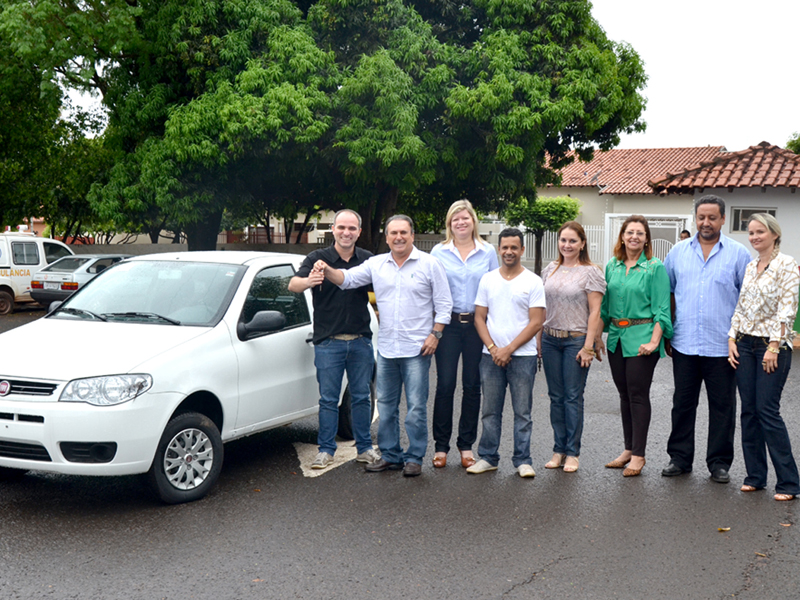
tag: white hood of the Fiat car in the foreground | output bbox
[0,318,217,381]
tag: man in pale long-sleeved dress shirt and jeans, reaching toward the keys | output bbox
[315,215,453,477]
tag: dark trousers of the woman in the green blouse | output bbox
[608,342,660,456]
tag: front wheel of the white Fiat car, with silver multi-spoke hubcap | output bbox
[148,412,223,504]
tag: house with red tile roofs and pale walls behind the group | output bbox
[538,142,800,262]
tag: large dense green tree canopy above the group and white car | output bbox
[0,0,646,248]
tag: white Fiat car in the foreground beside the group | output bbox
[0,252,377,503]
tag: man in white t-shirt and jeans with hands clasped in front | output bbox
[467,228,545,477]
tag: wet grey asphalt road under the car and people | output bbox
[0,311,800,600]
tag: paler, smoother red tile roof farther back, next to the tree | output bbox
[561,146,725,194]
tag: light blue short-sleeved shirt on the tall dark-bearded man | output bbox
[664,234,750,357]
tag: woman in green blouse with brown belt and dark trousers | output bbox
[601,215,672,477]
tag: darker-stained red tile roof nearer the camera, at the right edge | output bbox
[649,142,800,194]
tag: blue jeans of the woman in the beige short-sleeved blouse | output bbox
[542,333,589,456]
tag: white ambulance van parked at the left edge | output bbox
[0,232,74,315]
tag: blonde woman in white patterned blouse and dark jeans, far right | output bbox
[728,213,800,500]
